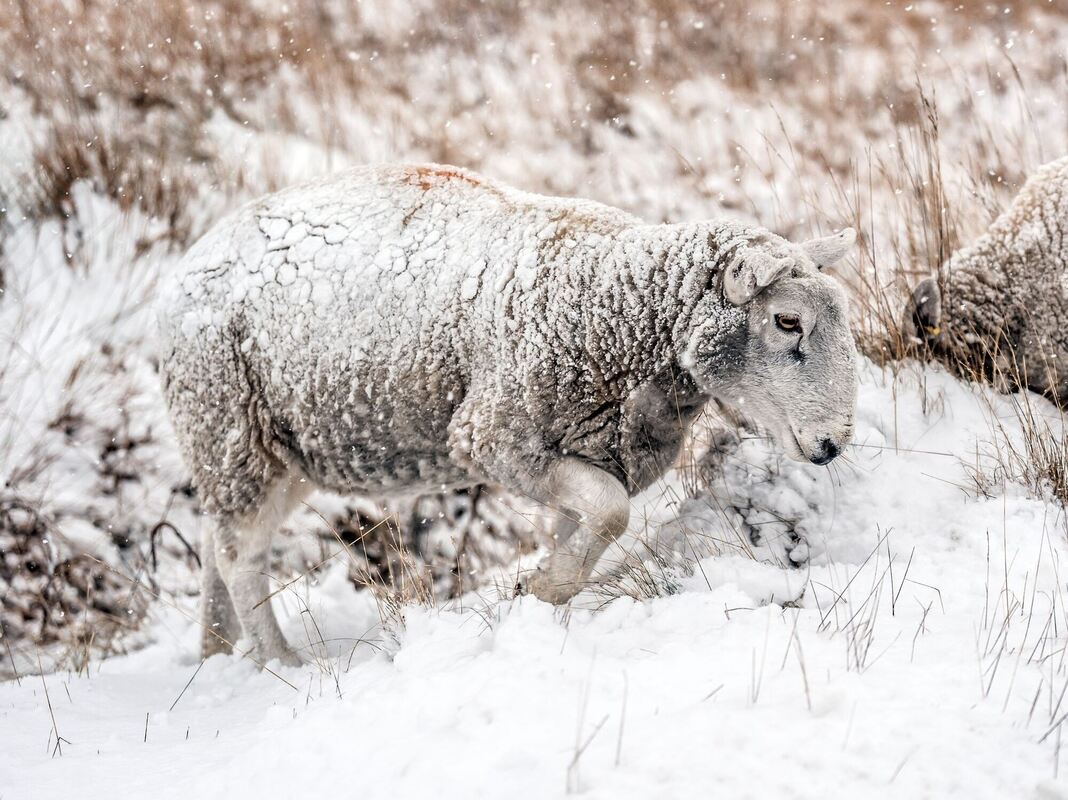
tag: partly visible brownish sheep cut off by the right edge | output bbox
[902,157,1068,406]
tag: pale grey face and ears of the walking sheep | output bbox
[684,229,857,464]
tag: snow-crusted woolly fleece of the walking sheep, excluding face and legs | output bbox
[160,166,796,516]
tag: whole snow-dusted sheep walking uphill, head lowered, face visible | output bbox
[159,164,857,665]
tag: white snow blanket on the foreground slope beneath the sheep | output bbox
[0,364,1068,800]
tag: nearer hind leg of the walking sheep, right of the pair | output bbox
[214,480,308,666]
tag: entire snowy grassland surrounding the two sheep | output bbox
[0,0,1068,798]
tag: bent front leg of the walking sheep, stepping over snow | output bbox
[520,458,630,605]
